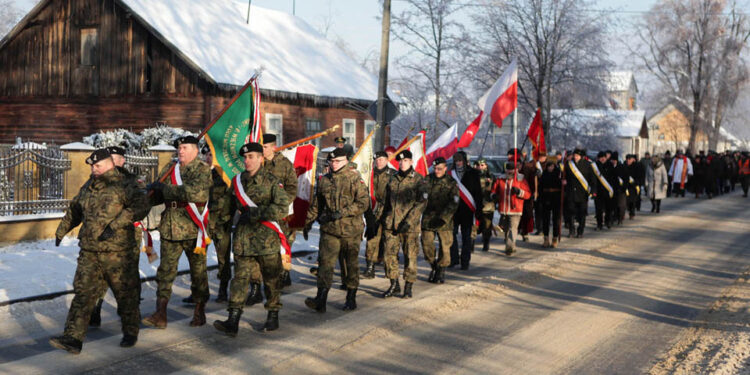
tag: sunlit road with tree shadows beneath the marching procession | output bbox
[0,194,750,374]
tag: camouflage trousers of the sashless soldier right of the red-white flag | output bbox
[318,233,362,289]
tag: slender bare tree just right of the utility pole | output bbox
[391,0,463,131]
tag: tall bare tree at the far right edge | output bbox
[632,0,748,151]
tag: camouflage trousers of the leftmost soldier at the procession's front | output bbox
[65,250,141,341]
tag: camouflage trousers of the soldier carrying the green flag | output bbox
[156,239,208,302]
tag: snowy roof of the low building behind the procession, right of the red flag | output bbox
[551,109,646,138]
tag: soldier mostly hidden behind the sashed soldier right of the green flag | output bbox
[260,134,297,290]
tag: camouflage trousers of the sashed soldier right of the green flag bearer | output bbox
[229,253,283,311]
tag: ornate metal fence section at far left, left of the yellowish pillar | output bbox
[0,139,70,216]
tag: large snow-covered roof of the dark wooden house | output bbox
[120,0,401,102]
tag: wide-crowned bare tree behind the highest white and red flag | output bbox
[465,0,611,140]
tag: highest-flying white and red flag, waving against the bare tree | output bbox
[475,59,518,128]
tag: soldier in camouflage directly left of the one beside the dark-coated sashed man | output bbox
[383,150,428,298]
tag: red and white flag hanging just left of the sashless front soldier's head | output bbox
[281,144,318,228]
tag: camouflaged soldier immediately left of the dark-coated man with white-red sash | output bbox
[422,157,460,284]
